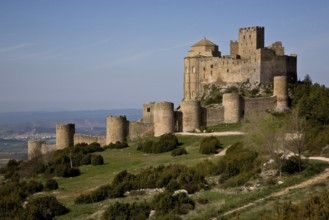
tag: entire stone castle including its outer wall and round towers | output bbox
[28,27,297,159]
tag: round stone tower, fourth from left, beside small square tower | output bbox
[154,102,175,137]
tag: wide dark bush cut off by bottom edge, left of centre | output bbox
[102,202,151,220]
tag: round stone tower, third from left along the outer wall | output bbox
[106,115,127,144]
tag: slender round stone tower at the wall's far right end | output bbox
[273,76,289,112]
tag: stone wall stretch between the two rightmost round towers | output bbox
[243,96,276,117]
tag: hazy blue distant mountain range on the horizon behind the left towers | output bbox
[0,109,142,138]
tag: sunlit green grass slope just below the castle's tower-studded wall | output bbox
[56,135,242,207]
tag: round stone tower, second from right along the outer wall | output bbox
[223,93,241,123]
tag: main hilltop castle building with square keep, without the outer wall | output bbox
[184,27,297,100]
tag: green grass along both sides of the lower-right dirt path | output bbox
[186,161,329,219]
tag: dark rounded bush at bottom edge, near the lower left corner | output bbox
[26,196,69,219]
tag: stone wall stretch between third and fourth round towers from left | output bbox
[128,121,154,140]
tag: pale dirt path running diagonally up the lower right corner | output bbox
[222,157,329,216]
